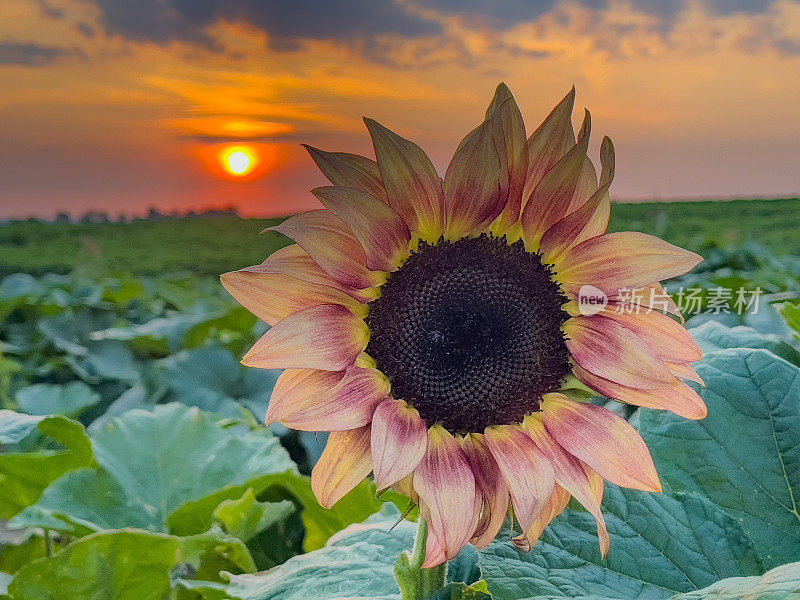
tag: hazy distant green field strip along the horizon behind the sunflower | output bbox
[0,198,800,277]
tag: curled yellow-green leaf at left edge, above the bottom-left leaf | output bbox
[0,411,93,519]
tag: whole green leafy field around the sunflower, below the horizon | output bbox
[0,200,800,600]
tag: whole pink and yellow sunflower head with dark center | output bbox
[222,84,706,567]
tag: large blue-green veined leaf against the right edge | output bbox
[640,349,800,568]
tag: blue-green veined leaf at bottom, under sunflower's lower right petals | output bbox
[478,484,763,600]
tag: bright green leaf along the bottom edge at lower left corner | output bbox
[8,529,252,600]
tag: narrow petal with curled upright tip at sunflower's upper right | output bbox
[539,137,614,264]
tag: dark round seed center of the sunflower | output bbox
[367,235,570,433]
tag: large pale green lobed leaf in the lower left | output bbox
[14,404,293,535]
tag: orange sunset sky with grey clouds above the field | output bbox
[0,0,800,218]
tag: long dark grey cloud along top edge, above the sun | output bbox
[87,0,440,47]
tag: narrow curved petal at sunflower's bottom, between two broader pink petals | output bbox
[461,433,511,548]
